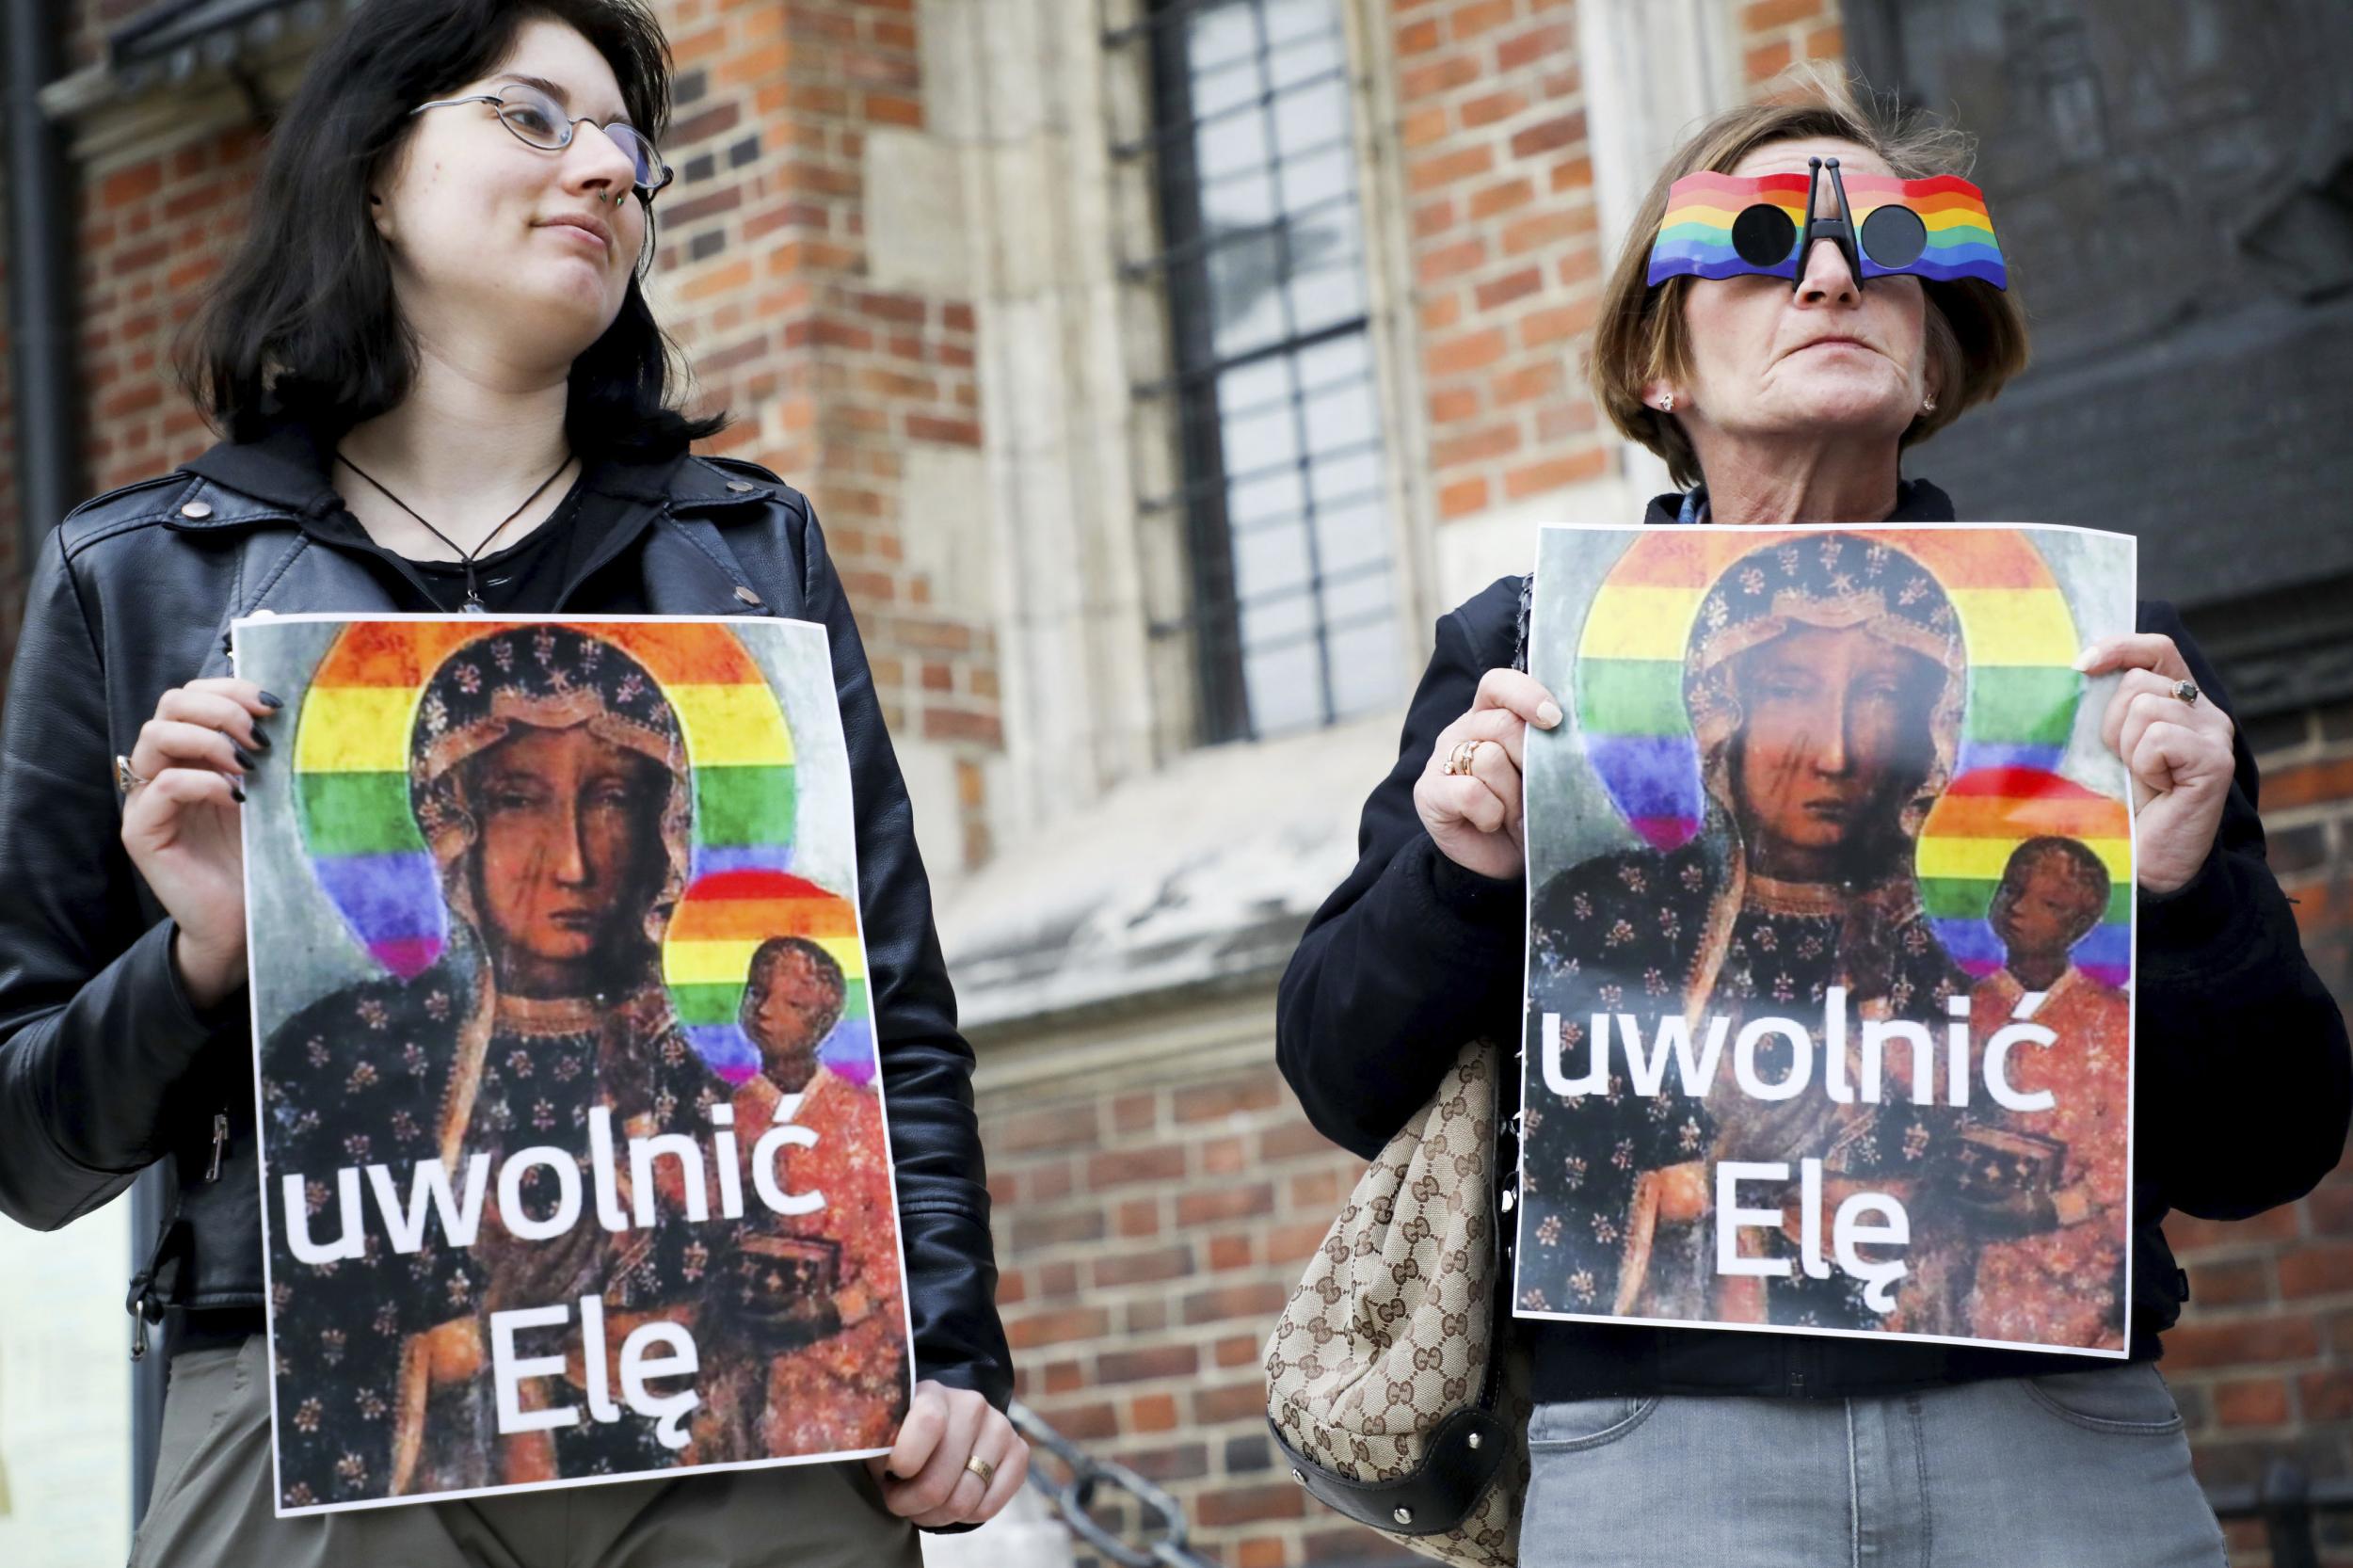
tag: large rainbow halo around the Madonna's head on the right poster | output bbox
[1572,527,2085,850]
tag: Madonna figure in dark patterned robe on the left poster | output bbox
[262,626,758,1507]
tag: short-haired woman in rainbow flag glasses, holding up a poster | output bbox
[1278,79,2353,1568]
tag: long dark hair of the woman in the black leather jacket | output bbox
[179,0,728,459]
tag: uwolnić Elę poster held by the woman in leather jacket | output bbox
[235,615,911,1516]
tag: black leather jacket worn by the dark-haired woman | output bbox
[0,424,1012,1408]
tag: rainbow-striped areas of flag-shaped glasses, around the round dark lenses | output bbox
[1650,172,2009,290]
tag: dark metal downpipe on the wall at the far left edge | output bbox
[0,0,83,567]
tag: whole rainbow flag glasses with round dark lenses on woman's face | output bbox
[1650,158,2009,290]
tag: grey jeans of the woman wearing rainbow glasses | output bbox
[1520,1363,2224,1568]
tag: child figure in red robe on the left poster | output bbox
[734,937,908,1452]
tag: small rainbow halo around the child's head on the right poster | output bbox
[1918,767,2132,986]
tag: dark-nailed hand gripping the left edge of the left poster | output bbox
[122,678,282,1008]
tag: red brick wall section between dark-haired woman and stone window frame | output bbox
[662,0,1002,864]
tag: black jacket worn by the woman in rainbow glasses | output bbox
[1275,483,2353,1399]
